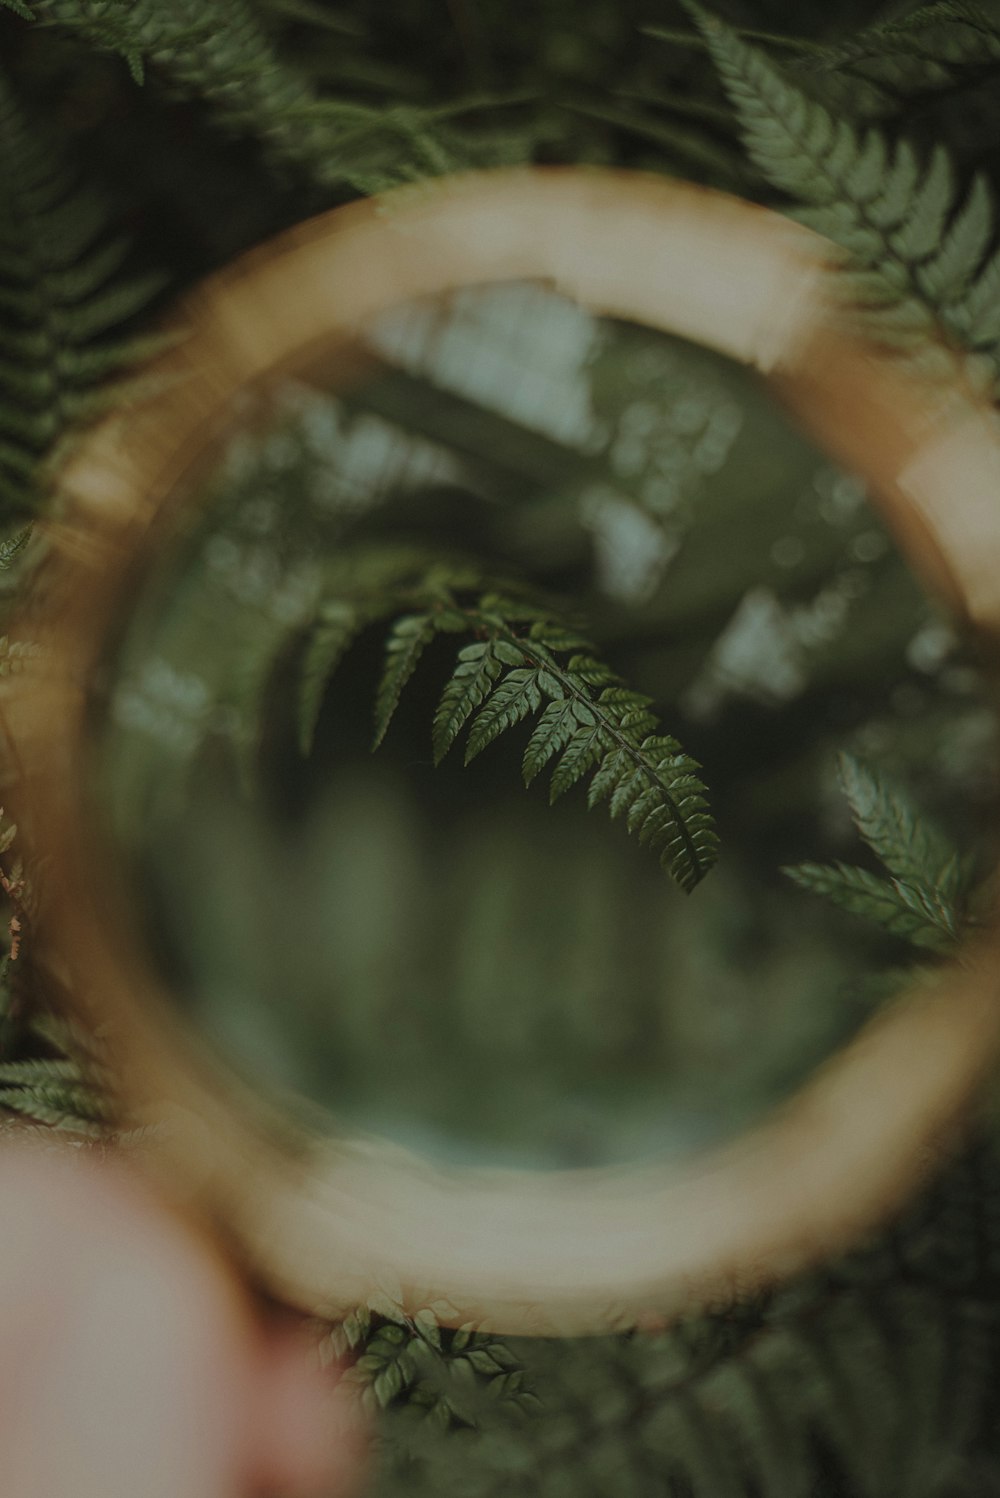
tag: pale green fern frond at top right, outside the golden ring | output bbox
[689,3,1000,376]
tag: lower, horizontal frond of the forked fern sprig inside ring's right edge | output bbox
[781,861,958,953]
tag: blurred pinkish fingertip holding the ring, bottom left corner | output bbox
[0,1146,364,1498]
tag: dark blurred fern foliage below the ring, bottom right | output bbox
[350,1141,1000,1498]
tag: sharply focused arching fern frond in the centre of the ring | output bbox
[299,569,719,890]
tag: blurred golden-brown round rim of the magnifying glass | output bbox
[11,169,1000,1333]
